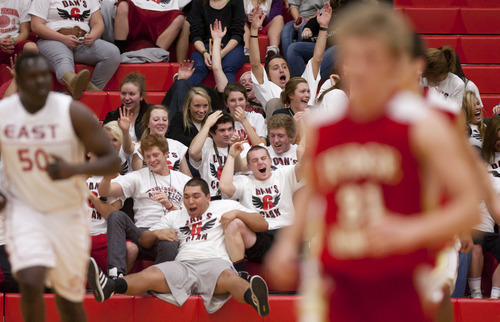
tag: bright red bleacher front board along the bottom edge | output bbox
[0,294,500,322]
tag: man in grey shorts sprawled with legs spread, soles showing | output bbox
[88,178,269,316]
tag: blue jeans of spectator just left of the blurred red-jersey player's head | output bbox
[287,41,337,80]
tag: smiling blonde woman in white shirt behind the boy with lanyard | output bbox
[133,105,192,177]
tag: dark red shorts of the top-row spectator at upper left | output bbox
[117,0,184,43]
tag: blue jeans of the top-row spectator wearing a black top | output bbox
[189,44,245,85]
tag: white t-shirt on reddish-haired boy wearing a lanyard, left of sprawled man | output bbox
[111,168,191,227]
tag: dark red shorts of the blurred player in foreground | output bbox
[327,274,433,322]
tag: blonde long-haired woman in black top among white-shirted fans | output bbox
[167,87,212,146]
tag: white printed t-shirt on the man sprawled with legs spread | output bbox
[149,200,253,261]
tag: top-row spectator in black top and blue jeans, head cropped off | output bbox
[189,0,245,85]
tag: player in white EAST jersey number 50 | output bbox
[0,53,120,321]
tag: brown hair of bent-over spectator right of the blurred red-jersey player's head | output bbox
[423,46,457,81]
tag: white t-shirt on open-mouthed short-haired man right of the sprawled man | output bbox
[231,166,302,230]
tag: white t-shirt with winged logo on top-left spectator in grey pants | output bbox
[29,0,101,32]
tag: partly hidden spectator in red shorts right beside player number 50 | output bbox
[86,152,139,270]
